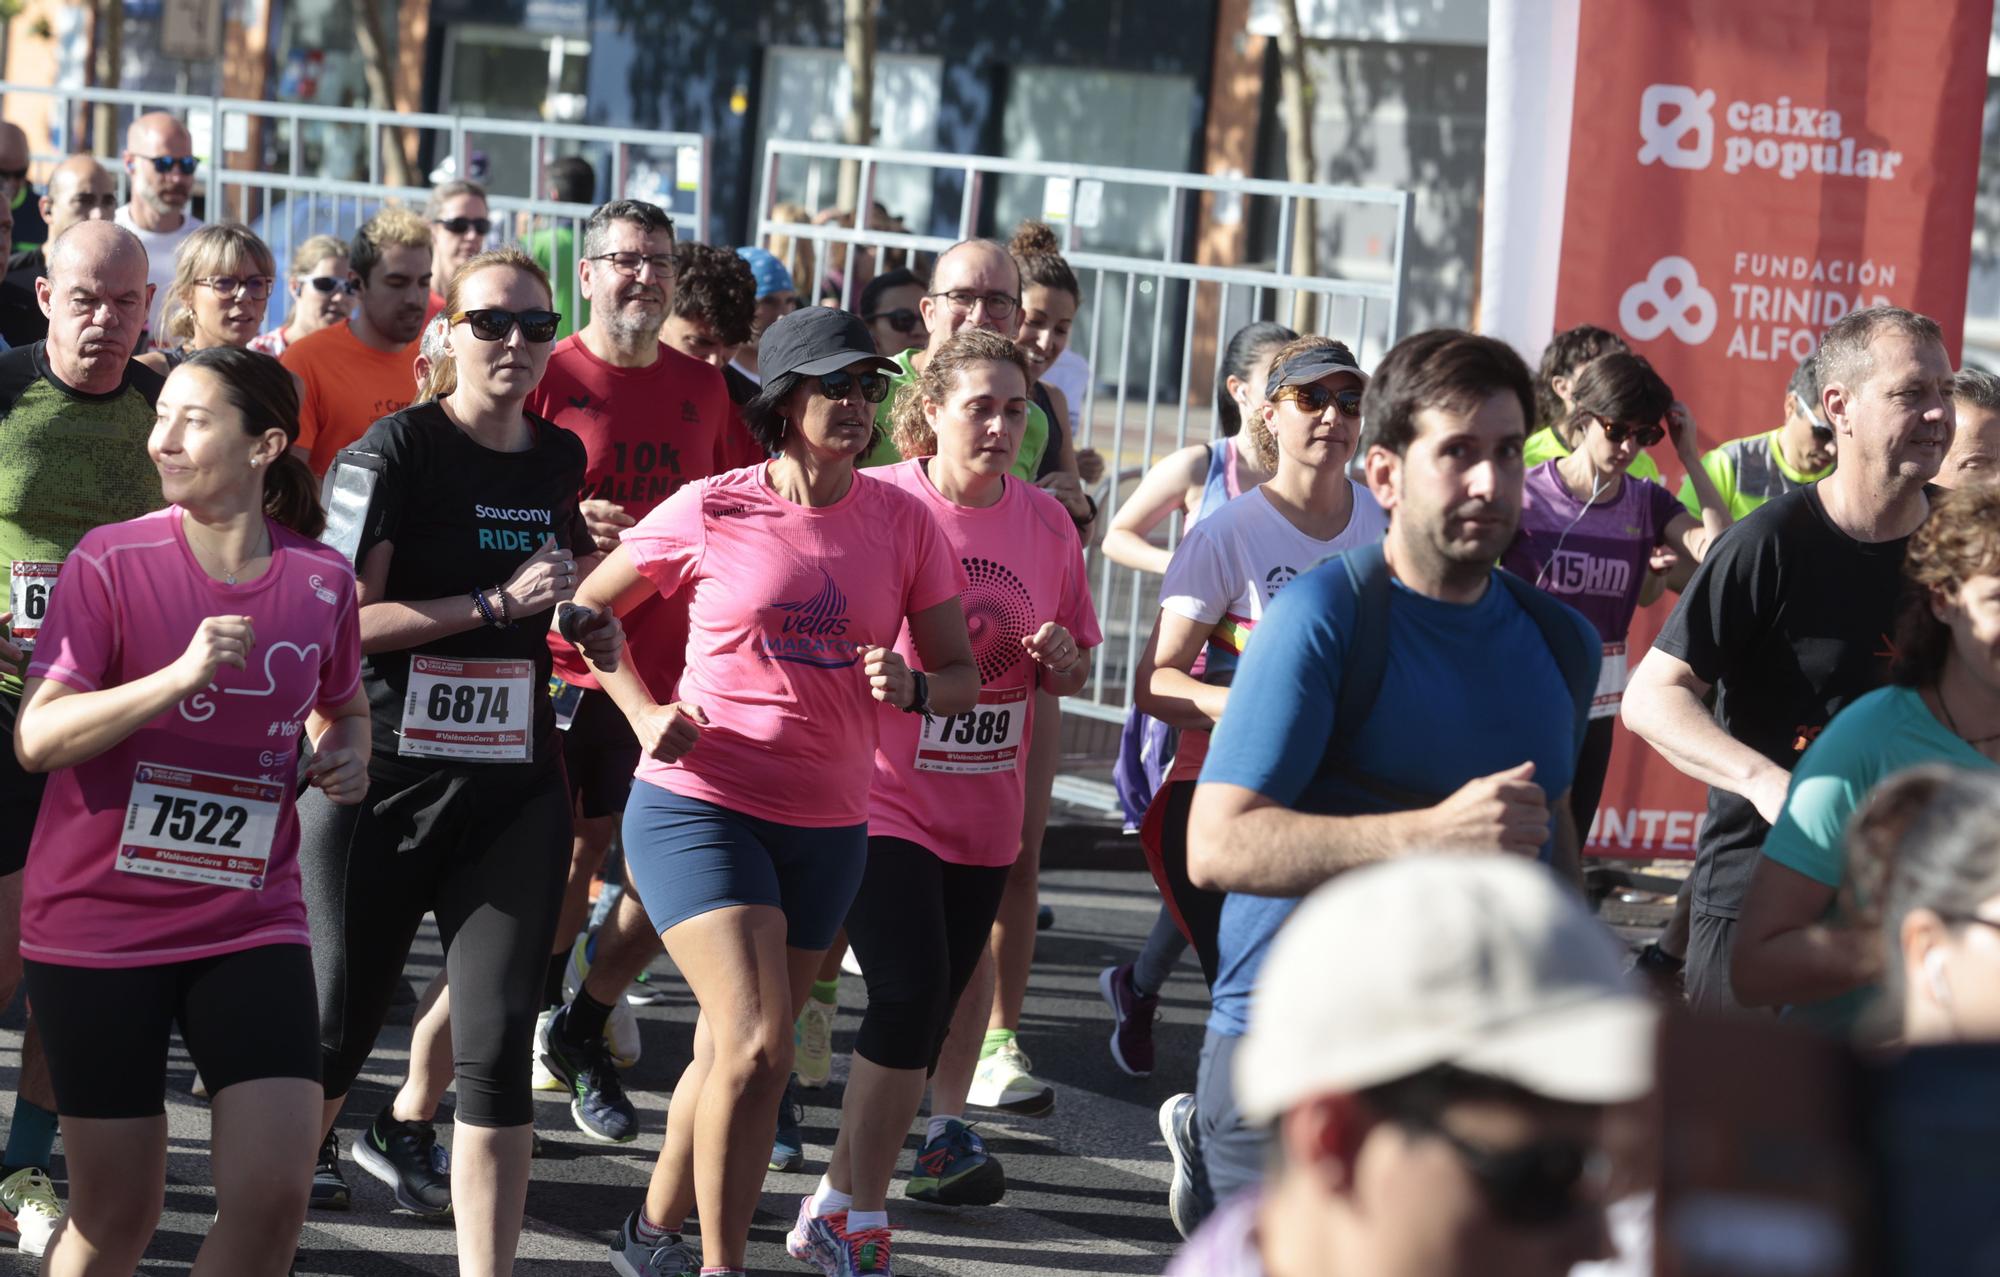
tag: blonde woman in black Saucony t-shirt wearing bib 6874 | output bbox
[300,250,618,1275]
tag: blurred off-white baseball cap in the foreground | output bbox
[1236,855,1656,1121]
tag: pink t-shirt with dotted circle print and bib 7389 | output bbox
[868,460,1104,865]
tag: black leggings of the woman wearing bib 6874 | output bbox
[298,759,570,1127]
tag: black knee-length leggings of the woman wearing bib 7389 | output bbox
[848,839,1008,1071]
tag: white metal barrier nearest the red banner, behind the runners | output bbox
[750,140,1410,760]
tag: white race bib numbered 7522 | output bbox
[118,763,284,891]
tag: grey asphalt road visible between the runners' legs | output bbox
[0,869,1206,1277]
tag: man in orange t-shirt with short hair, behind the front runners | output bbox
[280,208,430,474]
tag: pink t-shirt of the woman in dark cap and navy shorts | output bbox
[622,464,966,829]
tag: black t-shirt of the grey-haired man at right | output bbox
[1654,486,1910,919]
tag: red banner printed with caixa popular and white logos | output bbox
[1554,0,1992,857]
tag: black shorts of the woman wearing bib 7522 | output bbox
[24,945,320,1119]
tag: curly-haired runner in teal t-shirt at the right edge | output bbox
[1730,484,2000,1035]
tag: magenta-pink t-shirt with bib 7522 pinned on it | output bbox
[20,506,360,967]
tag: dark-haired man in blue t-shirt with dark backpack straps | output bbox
[1160,330,1602,1227]
